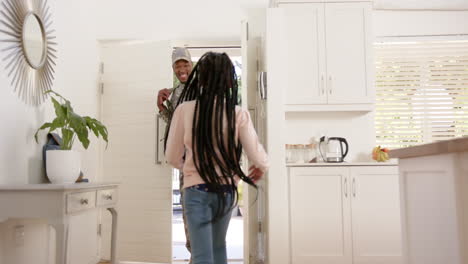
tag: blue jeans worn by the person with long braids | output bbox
[183,188,233,264]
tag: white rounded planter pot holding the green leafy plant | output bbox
[46,150,81,184]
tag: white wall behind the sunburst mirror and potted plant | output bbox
[0,0,99,264]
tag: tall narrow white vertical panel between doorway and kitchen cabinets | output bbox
[265,8,290,264]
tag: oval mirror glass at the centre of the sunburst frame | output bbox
[23,13,46,69]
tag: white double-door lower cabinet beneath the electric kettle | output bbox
[288,166,403,264]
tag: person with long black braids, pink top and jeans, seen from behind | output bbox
[166,52,268,264]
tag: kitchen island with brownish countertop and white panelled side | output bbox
[390,137,468,264]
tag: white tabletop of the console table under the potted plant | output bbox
[0,182,119,192]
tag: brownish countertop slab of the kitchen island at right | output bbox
[389,137,468,159]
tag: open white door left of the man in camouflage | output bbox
[101,41,173,263]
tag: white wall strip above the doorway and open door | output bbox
[97,0,267,41]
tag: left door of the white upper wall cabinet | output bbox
[283,4,327,104]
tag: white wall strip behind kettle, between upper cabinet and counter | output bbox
[286,112,375,162]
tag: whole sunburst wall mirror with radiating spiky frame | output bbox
[0,0,57,105]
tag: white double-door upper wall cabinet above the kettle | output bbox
[279,3,373,111]
